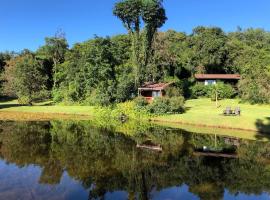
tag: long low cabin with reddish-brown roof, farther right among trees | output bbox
[195,74,241,85]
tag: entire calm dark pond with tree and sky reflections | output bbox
[0,121,270,200]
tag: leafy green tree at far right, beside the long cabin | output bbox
[226,29,270,103]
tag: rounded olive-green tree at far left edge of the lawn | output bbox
[4,53,48,104]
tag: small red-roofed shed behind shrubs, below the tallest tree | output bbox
[138,83,172,101]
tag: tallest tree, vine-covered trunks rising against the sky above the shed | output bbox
[113,0,167,86]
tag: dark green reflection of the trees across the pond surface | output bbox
[0,121,270,199]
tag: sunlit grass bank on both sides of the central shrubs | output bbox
[0,99,270,133]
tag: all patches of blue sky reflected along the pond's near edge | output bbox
[0,160,269,200]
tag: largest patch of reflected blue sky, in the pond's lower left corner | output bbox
[0,161,88,200]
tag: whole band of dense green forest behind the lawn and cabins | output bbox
[0,0,270,105]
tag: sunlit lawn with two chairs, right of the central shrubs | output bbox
[154,99,270,133]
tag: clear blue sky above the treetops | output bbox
[0,0,270,51]
